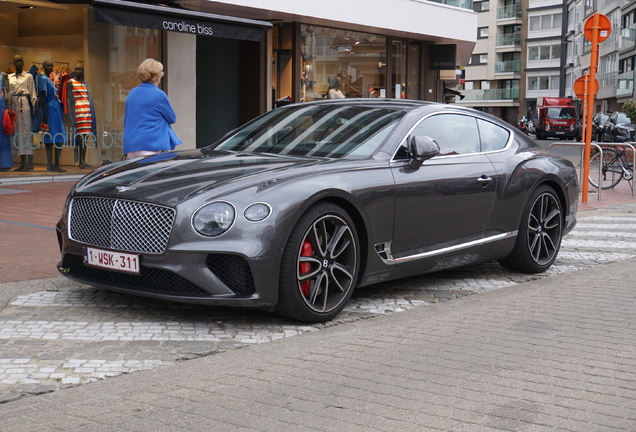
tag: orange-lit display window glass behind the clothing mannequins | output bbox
[0,5,162,166]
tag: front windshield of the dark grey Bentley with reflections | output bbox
[214,104,405,159]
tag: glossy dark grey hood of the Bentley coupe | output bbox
[74,149,333,206]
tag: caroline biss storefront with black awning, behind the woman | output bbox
[0,1,271,171]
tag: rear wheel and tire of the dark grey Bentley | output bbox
[499,186,564,273]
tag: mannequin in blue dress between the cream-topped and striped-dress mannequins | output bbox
[38,60,66,172]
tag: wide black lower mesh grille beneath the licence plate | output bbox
[62,254,210,297]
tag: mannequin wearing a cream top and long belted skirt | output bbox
[9,55,37,171]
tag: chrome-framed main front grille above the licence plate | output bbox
[69,197,175,254]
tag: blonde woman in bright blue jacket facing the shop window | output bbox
[124,59,181,159]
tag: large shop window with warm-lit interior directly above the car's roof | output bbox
[300,25,389,101]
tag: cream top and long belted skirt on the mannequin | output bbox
[9,71,37,156]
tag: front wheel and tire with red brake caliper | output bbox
[275,203,360,323]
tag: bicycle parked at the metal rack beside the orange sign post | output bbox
[588,146,634,190]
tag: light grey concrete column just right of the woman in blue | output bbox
[164,32,197,150]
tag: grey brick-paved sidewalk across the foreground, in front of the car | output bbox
[0,255,636,432]
